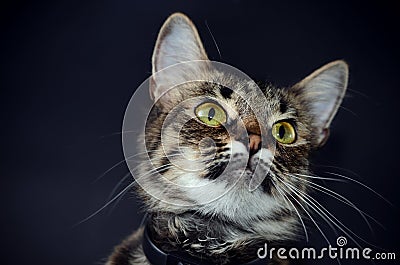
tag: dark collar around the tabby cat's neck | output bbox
[142,218,267,265]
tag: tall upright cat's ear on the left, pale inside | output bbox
[150,13,208,99]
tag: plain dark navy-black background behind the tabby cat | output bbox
[0,0,400,265]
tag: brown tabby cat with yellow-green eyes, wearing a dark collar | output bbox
[106,13,348,265]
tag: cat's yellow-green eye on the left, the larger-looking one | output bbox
[195,102,226,127]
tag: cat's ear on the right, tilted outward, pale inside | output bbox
[293,60,349,146]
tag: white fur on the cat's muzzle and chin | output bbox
[177,141,281,224]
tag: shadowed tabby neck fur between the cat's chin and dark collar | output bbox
[148,209,266,264]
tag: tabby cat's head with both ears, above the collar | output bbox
[134,14,348,237]
